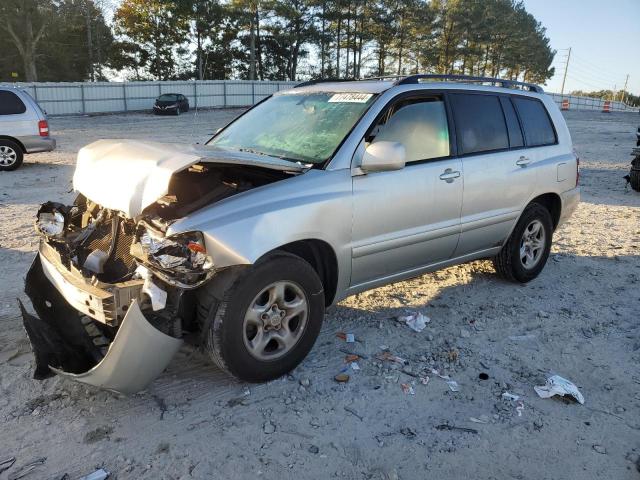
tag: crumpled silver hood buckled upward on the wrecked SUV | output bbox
[73,140,306,218]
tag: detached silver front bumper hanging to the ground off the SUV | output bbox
[20,254,182,394]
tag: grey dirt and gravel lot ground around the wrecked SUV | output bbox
[0,110,640,480]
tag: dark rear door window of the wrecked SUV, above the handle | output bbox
[451,93,509,154]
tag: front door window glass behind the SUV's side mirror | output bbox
[372,98,449,162]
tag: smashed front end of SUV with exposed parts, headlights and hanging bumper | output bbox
[22,195,213,394]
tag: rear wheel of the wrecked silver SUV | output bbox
[493,203,553,283]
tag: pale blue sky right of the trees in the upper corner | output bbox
[524,0,640,95]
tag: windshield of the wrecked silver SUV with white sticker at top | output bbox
[209,92,375,163]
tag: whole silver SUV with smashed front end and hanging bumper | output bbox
[23,75,580,393]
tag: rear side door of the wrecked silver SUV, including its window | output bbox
[450,92,536,257]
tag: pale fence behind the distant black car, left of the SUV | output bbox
[7,80,298,115]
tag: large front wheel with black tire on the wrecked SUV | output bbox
[197,252,324,382]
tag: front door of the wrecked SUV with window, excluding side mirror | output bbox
[351,94,462,287]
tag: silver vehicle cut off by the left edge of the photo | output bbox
[0,85,56,171]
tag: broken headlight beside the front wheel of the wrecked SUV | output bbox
[140,230,213,281]
